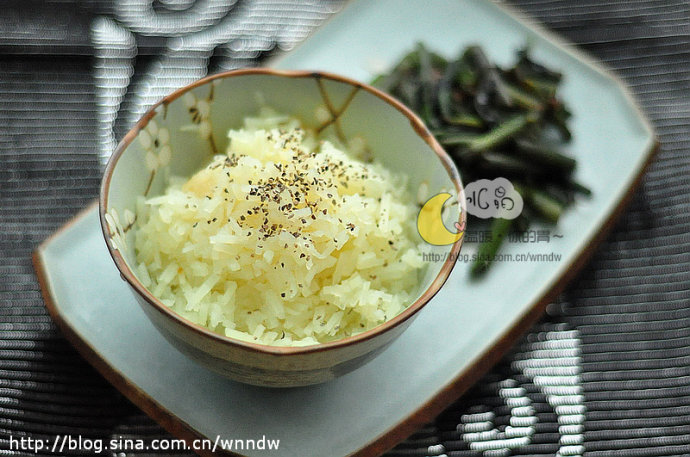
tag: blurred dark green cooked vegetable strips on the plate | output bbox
[372,43,590,276]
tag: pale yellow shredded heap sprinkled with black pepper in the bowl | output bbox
[135,109,423,346]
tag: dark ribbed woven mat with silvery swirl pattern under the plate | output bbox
[0,0,690,457]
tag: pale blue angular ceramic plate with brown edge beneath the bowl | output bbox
[35,0,656,457]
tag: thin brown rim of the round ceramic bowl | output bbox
[98,67,467,355]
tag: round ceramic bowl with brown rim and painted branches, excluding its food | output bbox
[99,69,465,387]
